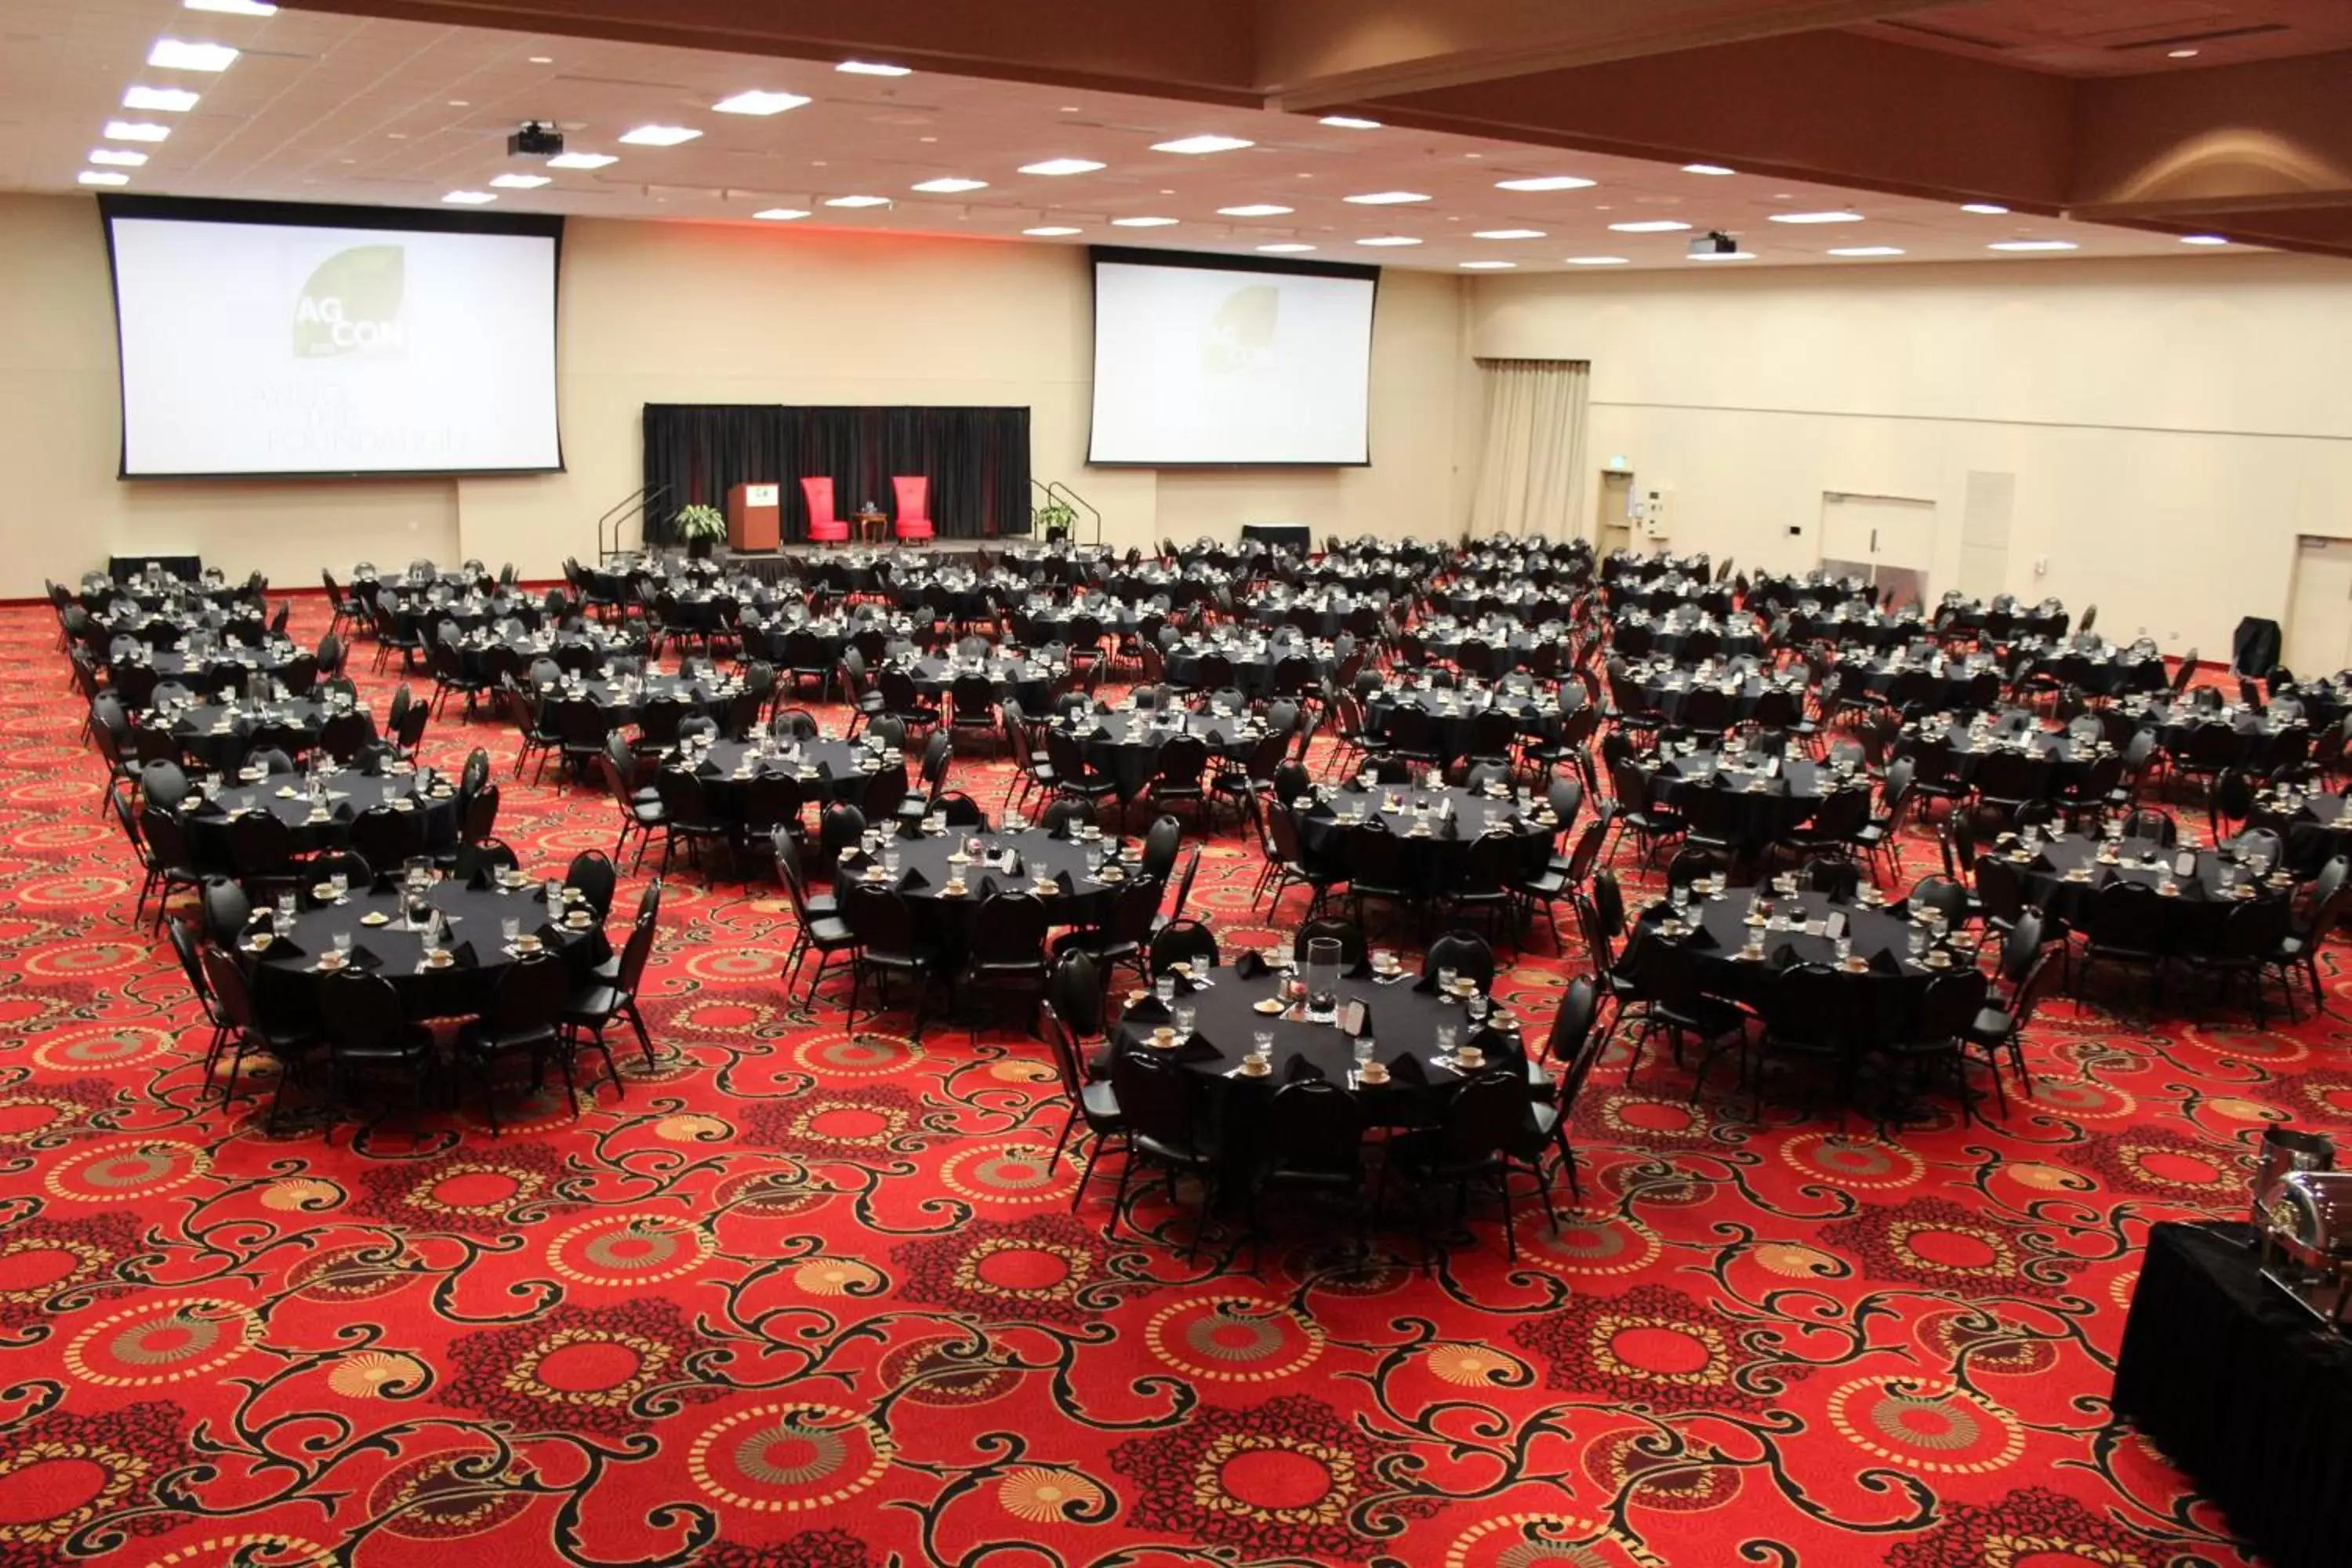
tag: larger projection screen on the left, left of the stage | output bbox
[101,198,562,480]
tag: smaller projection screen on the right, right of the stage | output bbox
[1087,247,1381,468]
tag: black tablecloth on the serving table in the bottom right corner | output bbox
[2114,1225,2352,1568]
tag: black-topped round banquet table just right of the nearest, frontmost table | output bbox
[1637,886,1966,1041]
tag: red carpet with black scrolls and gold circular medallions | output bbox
[0,600,2314,1568]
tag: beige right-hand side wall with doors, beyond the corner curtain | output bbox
[1468,256,2352,659]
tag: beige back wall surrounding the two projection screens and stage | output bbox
[0,198,1475,597]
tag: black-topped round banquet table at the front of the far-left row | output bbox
[240,881,604,1020]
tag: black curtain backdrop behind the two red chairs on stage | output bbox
[644,402,1030,546]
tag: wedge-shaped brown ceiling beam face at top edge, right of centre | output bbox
[1258,0,1940,113]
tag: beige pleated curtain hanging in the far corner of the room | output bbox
[1470,360,1592,541]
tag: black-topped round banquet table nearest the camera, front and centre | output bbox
[1115,966,1524,1123]
